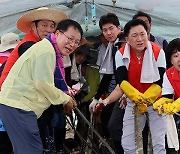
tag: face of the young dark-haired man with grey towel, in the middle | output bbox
[102,23,121,42]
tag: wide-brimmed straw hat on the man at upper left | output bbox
[17,7,68,33]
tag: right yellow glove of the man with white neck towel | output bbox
[144,84,162,106]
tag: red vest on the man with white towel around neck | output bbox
[120,42,161,93]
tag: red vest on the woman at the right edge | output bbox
[166,66,180,98]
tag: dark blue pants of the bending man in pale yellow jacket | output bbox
[0,104,43,154]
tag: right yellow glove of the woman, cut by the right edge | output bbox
[163,98,180,114]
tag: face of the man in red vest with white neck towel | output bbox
[126,25,148,53]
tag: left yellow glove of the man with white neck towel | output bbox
[120,80,146,104]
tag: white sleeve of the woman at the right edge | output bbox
[162,72,174,95]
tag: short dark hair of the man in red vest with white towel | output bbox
[124,19,148,37]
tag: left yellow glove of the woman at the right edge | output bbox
[153,97,173,114]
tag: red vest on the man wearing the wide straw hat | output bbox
[0,30,39,88]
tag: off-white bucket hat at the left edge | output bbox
[0,33,20,52]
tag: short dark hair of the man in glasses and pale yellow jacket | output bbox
[56,19,83,38]
